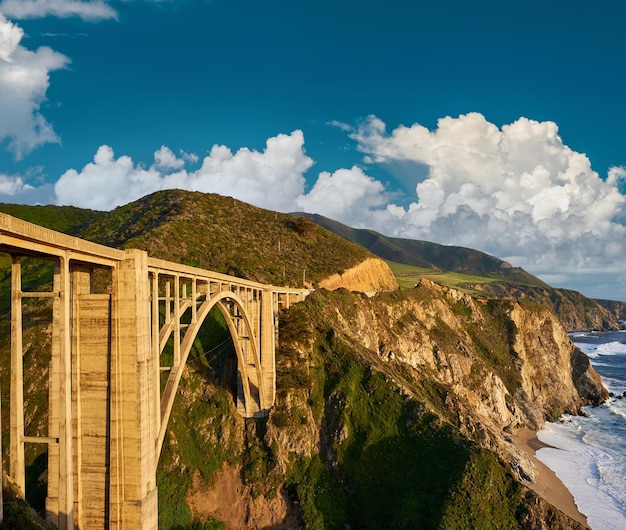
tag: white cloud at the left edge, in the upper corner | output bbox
[0,14,69,158]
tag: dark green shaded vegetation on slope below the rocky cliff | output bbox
[271,294,523,529]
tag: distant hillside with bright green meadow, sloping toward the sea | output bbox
[295,213,622,331]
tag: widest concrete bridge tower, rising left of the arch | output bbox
[110,250,160,530]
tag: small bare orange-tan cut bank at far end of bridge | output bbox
[319,258,398,292]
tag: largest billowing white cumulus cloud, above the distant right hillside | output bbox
[351,113,626,271]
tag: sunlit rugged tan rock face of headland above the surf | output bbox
[292,280,608,438]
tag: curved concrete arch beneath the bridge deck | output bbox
[157,291,271,456]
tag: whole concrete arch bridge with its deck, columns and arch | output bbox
[0,214,308,530]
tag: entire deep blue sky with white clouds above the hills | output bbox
[0,0,626,300]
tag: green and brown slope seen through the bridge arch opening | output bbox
[157,309,241,529]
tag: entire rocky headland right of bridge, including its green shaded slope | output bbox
[182,280,606,529]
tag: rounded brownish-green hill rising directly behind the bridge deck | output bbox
[80,190,372,286]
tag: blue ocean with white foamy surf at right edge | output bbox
[537,331,626,530]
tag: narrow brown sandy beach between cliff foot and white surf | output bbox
[511,429,589,527]
